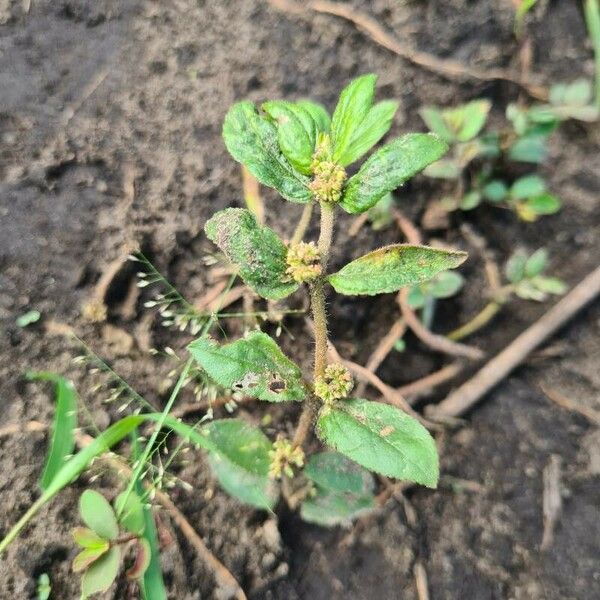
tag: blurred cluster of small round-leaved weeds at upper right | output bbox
[420,80,599,221]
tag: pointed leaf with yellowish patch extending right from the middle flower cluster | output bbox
[328,244,467,296]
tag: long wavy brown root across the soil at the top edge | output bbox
[302,0,548,100]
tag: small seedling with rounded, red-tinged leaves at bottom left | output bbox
[73,490,151,598]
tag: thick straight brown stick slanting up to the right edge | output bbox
[430,267,600,417]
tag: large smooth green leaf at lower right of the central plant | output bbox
[317,400,439,488]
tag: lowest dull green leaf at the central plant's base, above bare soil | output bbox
[300,490,377,527]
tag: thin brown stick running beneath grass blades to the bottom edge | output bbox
[76,433,246,600]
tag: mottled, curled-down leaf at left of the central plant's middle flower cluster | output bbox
[204,208,299,300]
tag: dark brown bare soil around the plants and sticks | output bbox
[0,0,600,600]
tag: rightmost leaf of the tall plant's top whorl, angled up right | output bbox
[340,133,448,214]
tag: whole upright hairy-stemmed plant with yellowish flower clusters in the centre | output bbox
[189,75,466,524]
